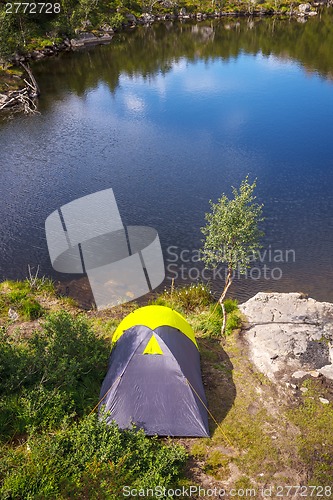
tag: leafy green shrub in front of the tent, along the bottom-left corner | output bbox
[0,415,187,500]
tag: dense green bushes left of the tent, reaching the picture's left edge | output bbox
[0,311,110,440]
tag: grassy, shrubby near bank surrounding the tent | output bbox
[0,280,333,500]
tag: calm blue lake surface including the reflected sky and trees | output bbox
[0,14,333,301]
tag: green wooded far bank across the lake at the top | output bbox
[0,0,331,67]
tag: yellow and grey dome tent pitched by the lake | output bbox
[100,306,209,437]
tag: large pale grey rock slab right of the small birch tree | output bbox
[239,292,333,380]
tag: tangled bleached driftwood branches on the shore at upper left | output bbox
[0,62,40,114]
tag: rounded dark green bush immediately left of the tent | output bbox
[29,311,110,414]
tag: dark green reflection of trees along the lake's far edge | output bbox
[34,12,333,105]
